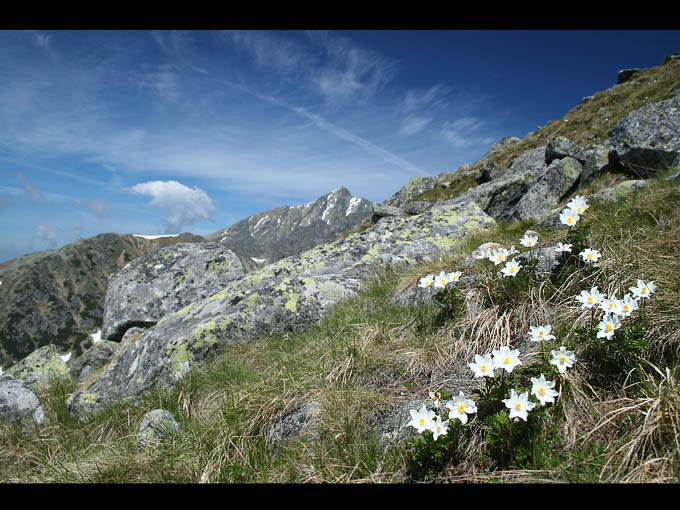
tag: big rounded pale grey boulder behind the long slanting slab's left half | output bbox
[102,242,244,341]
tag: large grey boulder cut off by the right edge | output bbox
[609,96,680,179]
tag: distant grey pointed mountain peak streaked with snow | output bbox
[206,188,373,268]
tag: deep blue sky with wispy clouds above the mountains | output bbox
[0,30,680,261]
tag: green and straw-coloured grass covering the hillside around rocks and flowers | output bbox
[0,53,680,483]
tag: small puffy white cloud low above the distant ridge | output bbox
[128,181,215,233]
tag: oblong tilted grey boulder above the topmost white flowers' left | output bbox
[512,156,583,221]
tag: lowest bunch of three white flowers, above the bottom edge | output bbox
[408,391,477,441]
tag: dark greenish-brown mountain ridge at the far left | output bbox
[0,234,202,367]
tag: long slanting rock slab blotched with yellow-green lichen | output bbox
[70,198,495,413]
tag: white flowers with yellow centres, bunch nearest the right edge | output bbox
[574,280,656,340]
